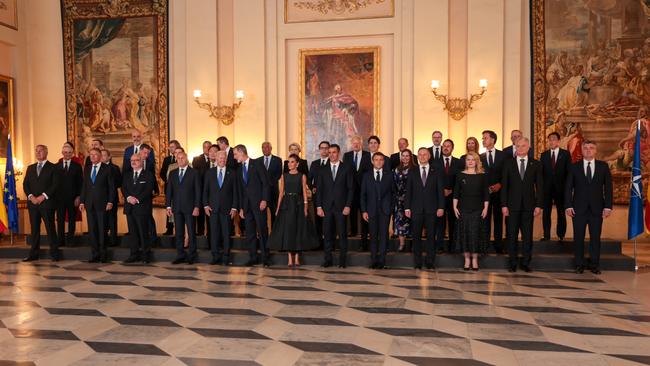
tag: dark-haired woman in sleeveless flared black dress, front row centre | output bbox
[268,154,318,267]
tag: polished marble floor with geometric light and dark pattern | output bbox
[0,260,650,366]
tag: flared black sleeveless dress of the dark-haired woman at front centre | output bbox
[268,173,319,252]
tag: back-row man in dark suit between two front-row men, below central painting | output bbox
[343,136,372,251]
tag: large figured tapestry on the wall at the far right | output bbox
[531,0,650,203]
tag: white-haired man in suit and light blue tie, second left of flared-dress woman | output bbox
[203,151,239,266]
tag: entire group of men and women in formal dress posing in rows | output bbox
[23,130,612,273]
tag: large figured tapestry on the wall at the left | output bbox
[62,0,169,174]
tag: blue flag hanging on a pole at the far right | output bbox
[627,120,643,240]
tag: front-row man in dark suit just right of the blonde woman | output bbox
[500,137,544,272]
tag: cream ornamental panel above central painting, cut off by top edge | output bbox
[284,0,395,23]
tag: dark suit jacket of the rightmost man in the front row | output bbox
[564,160,613,215]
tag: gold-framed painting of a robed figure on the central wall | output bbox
[298,47,380,161]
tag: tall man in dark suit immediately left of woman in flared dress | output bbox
[234,145,271,267]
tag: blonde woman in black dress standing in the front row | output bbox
[453,151,490,271]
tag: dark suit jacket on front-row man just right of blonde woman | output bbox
[500,158,544,211]
